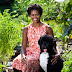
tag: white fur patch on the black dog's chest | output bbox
[40,52,49,72]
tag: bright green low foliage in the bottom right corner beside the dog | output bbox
[62,51,72,72]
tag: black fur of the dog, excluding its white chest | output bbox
[38,35,63,72]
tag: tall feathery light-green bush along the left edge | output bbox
[0,10,21,64]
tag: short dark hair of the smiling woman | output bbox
[27,4,43,16]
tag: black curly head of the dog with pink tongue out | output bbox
[38,35,54,52]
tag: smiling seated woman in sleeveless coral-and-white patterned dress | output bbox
[12,4,60,72]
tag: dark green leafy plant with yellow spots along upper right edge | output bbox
[56,0,72,48]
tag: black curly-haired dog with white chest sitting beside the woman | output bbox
[38,35,63,72]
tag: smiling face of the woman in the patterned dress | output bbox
[30,10,41,23]
